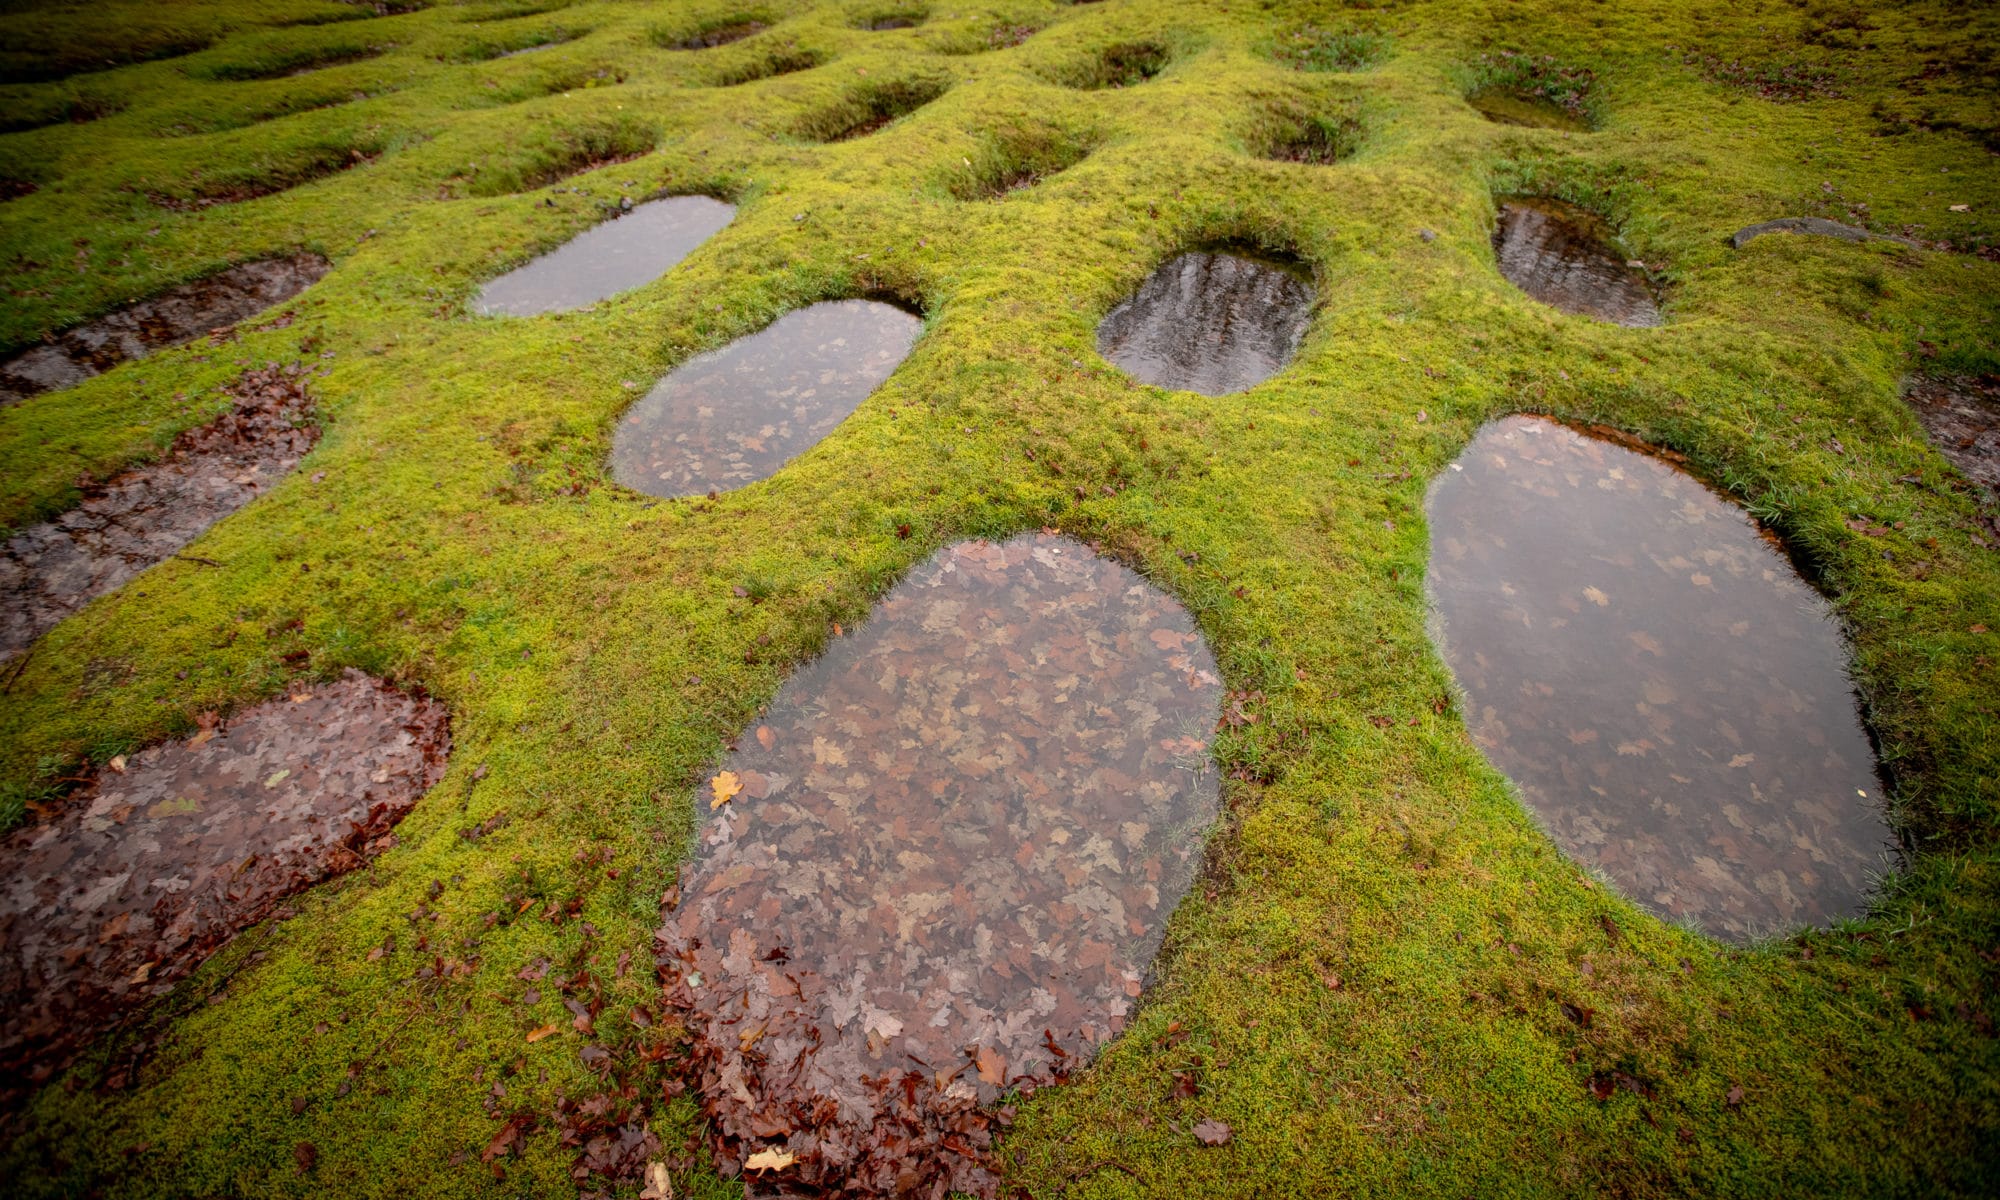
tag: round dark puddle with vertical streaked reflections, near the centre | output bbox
[1098,250,1314,396]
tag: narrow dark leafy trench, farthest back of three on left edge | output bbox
[0,254,330,404]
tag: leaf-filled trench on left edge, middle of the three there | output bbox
[0,364,320,662]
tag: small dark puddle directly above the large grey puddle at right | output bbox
[1494,200,1660,326]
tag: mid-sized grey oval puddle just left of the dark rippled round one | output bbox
[612,300,924,496]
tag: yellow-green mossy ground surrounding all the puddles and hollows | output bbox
[0,0,2000,1196]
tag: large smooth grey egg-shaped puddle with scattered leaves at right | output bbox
[1430,416,1892,940]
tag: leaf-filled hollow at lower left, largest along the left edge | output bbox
[0,670,450,1102]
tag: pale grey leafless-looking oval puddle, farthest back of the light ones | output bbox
[472,196,736,316]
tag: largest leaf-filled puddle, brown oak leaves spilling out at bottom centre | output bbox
[658,534,1222,1194]
